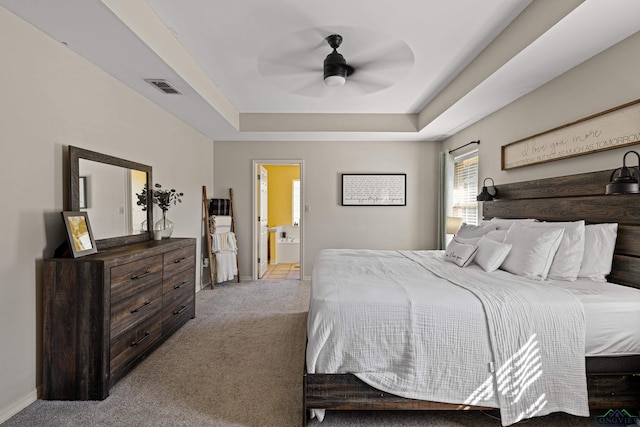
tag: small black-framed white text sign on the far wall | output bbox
[342,173,407,206]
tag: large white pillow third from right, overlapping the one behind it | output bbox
[500,223,564,280]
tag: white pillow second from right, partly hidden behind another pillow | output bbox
[527,221,585,281]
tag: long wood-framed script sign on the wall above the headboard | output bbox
[501,99,640,170]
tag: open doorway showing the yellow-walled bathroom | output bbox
[252,160,304,280]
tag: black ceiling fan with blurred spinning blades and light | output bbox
[258,27,414,98]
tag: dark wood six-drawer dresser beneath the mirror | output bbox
[43,239,196,400]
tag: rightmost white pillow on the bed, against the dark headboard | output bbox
[578,224,618,282]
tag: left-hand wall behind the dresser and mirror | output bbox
[0,7,213,423]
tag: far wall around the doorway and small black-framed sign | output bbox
[214,141,440,277]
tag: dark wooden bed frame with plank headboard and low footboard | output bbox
[303,170,640,426]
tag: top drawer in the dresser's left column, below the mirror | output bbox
[111,255,162,304]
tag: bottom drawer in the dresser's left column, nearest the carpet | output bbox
[109,311,162,381]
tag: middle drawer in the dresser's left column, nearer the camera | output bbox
[110,283,162,339]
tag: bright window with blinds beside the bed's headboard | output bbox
[453,151,478,224]
